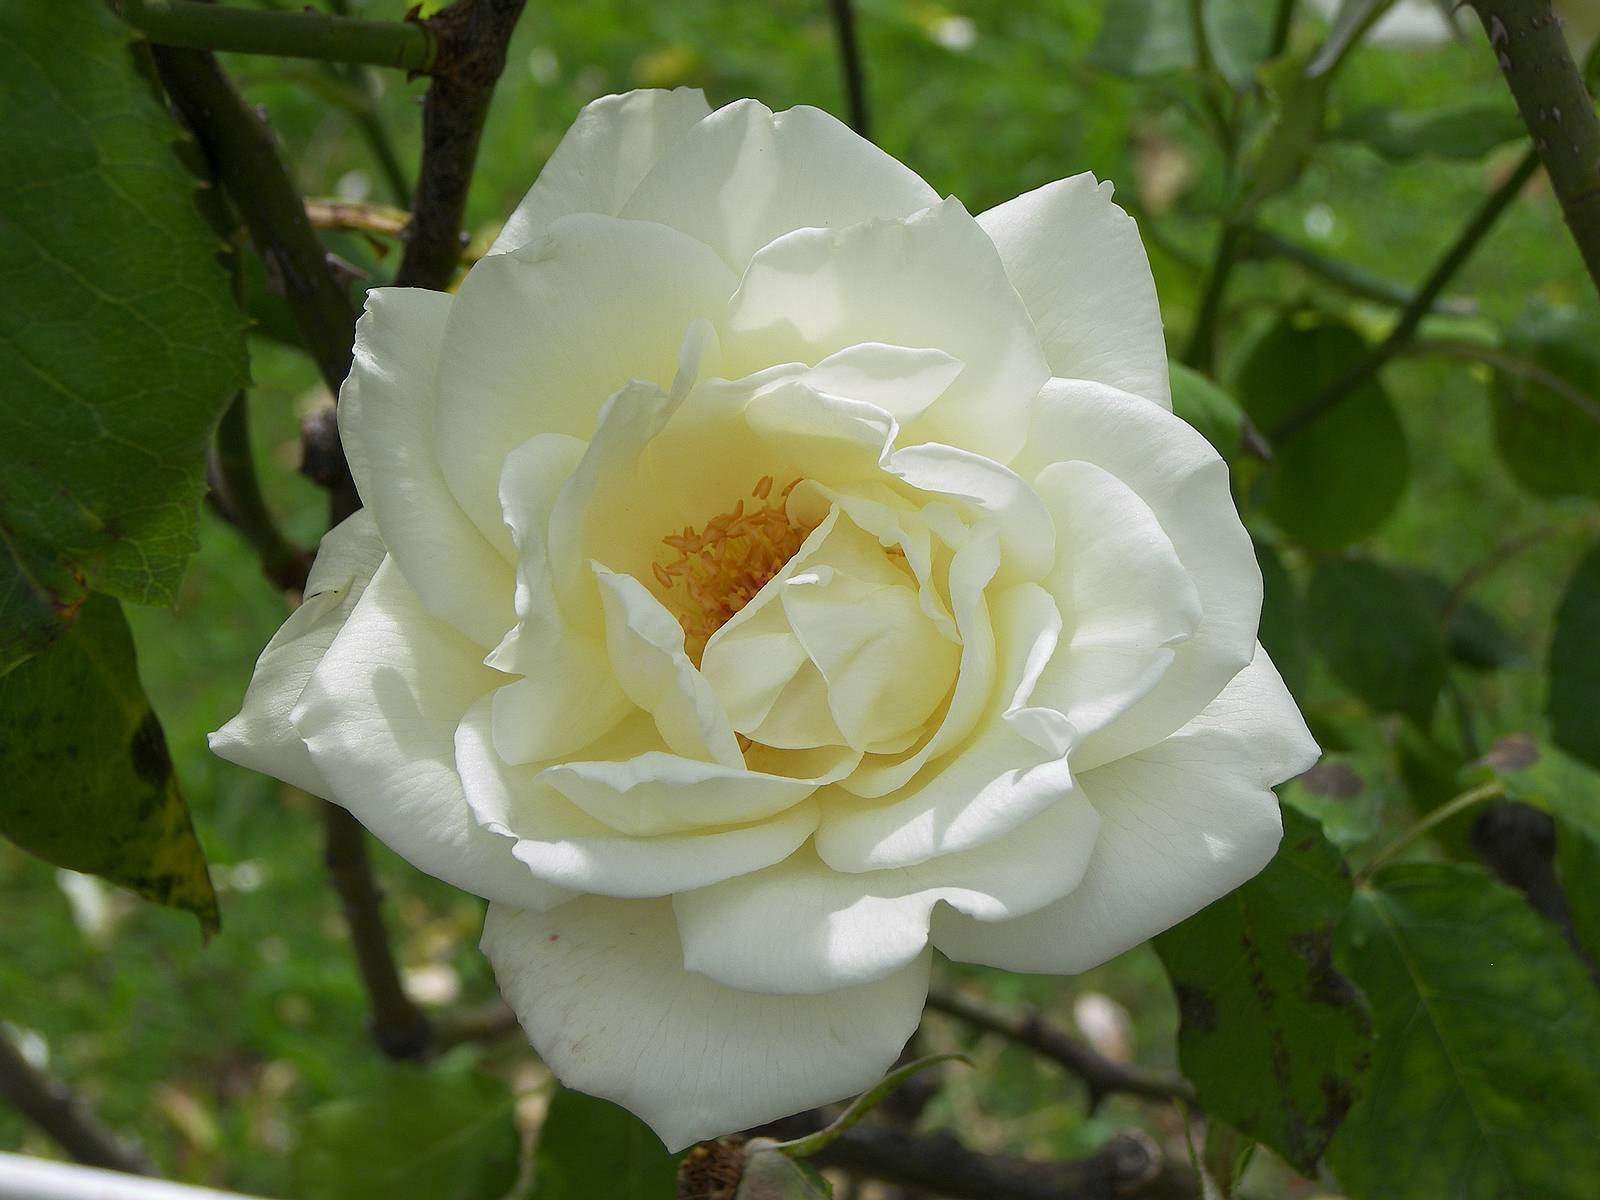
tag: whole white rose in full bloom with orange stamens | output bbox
[211,90,1317,1147]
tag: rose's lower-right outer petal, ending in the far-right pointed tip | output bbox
[933,650,1317,974]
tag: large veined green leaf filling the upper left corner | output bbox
[0,3,246,669]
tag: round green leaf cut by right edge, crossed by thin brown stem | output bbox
[1493,309,1600,499]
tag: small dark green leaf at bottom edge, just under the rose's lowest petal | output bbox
[531,1088,678,1200]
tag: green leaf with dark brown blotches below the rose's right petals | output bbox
[1155,810,1371,1174]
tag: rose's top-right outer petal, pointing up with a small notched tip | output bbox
[978,173,1173,408]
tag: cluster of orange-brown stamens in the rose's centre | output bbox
[650,475,814,664]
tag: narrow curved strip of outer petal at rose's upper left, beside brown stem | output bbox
[339,288,515,648]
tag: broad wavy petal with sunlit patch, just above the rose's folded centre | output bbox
[723,200,1050,462]
